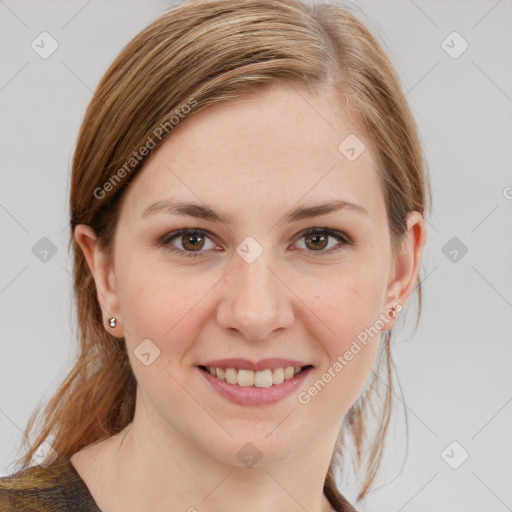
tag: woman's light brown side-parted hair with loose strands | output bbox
[9,0,431,503]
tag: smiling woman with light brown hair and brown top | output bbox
[0,0,430,512]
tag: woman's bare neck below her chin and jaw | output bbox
[79,390,339,512]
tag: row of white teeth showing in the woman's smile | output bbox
[207,366,302,388]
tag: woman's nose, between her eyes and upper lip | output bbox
[217,251,294,341]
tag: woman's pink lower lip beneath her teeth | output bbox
[197,367,313,405]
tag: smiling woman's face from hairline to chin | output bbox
[78,86,426,465]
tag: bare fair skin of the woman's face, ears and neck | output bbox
[71,85,426,512]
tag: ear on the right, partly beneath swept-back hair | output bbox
[381,212,427,332]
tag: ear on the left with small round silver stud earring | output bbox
[74,224,124,337]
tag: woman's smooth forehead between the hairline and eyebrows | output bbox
[120,85,384,221]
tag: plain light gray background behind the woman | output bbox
[0,0,512,512]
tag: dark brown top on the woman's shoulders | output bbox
[0,456,357,512]
